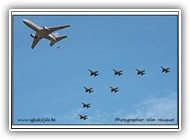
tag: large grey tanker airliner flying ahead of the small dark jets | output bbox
[23,19,70,49]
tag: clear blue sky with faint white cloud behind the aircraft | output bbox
[13,16,178,124]
